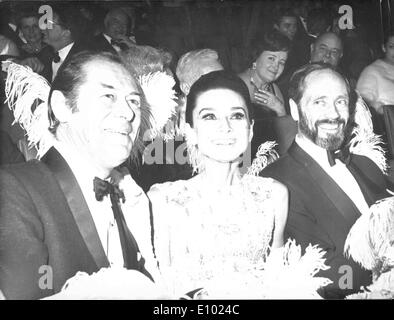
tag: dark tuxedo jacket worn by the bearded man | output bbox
[261,143,388,299]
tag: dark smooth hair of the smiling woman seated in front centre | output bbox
[186,70,254,127]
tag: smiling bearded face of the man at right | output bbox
[298,70,349,150]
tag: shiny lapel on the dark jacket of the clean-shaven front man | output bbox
[42,148,109,269]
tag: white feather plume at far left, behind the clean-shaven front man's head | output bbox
[5,63,52,158]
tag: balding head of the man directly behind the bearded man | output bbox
[311,32,343,67]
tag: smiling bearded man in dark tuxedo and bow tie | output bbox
[262,63,388,299]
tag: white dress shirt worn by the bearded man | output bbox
[295,134,369,214]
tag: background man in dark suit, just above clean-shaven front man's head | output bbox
[92,8,136,53]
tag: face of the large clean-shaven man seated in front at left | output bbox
[69,59,141,170]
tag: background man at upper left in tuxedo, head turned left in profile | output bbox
[41,5,89,82]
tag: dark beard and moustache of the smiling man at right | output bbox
[298,112,346,151]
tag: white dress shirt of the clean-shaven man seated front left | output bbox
[54,140,156,276]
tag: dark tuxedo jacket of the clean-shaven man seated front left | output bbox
[0,149,145,299]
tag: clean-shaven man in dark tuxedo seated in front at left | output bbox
[0,51,155,299]
